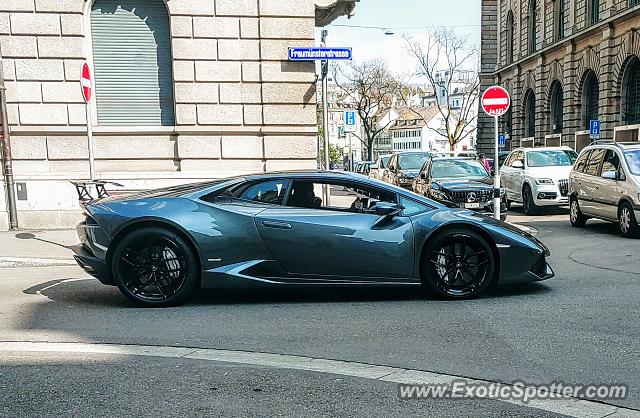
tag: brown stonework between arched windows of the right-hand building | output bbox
[478,0,640,150]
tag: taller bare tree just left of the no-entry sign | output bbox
[405,28,480,151]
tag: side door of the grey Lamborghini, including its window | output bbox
[255,178,414,281]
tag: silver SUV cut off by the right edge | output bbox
[569,141,640,237]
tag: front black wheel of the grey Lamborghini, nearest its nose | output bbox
[421,228,495,299]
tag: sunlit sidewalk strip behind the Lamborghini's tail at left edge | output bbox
[0,229,79,260]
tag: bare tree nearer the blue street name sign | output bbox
[333,60,400,160]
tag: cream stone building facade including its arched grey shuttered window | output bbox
[0,0,356,229]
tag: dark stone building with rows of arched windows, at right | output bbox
[478,0,640,151]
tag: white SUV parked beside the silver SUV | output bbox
[500,147,578,215]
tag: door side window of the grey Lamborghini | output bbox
[287,180,395,213]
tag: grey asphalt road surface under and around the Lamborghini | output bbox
[0,208,640,416]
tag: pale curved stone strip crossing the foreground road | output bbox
[0,341,640,418]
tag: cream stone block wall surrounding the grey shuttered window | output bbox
[0,0,317,227]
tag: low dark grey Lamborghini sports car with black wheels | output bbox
[73,171,554,306]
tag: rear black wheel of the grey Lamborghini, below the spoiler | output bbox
[111,227,200,308]
